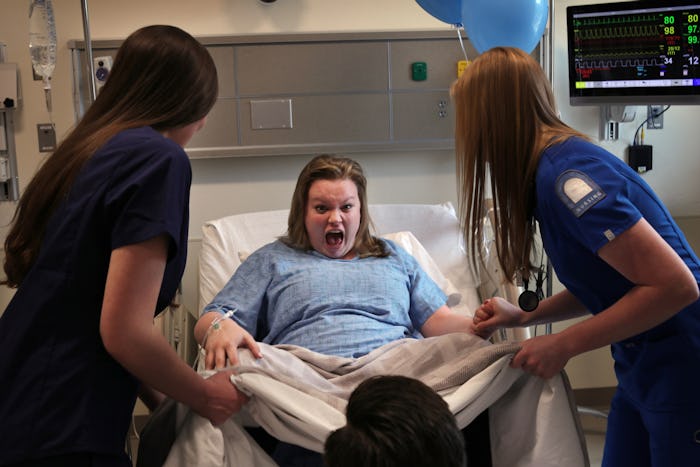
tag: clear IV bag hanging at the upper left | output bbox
[29,0,56,83]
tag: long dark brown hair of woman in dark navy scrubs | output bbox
[2,25,218,287]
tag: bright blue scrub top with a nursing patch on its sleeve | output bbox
[535,138,700,405]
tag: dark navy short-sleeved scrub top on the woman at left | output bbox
[0,127,192,464]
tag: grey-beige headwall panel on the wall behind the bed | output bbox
[69,30,476,157]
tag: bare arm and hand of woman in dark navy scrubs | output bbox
[100,235,246,424]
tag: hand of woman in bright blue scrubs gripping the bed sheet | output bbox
[510,334,571,379]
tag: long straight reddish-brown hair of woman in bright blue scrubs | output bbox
[452,47,586,280]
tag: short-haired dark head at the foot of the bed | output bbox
[324,376,466,467]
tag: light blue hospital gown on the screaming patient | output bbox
[203,240,447,357]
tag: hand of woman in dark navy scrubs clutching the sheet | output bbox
[192,371,248,426]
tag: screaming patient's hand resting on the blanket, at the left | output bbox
[204,319,262,370]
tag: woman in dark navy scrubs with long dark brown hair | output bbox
[0,26,252,467]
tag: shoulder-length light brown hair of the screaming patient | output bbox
[280,154,389,257]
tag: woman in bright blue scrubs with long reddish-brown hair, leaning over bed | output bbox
[452,48,700,467]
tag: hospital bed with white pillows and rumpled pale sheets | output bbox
[139,203,589,467]
